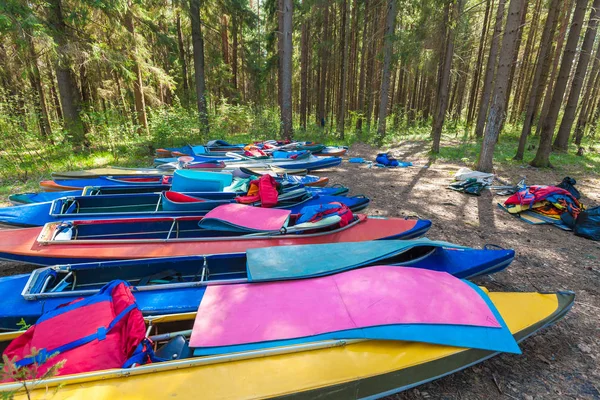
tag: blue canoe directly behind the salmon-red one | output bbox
[0,188,370,226]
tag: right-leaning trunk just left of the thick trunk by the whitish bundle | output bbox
[431,0,463,154]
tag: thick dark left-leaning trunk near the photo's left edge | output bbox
[48,0,86,145]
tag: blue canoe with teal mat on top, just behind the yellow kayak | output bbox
[0,239,514,330]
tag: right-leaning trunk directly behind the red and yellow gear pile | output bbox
[531,0,588,167]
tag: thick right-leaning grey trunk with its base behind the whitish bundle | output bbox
[477,0,526,172]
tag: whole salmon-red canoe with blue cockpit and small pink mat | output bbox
[0,205,431,265]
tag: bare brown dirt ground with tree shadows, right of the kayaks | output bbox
[0,140,600,400]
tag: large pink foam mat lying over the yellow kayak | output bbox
[190,266,501,347]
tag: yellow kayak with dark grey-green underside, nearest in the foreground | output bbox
[0,292,575,400]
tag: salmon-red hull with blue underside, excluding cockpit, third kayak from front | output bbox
[0,215,431,265]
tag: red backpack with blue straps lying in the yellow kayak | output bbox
[4,281,146,381]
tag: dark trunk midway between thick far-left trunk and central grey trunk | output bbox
[190,0,209,135]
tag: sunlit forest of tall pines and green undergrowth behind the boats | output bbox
[0,0,600,185]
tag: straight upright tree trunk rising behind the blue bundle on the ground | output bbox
[377,0,396,144]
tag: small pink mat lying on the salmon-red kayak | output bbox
[199,204,291,231]
